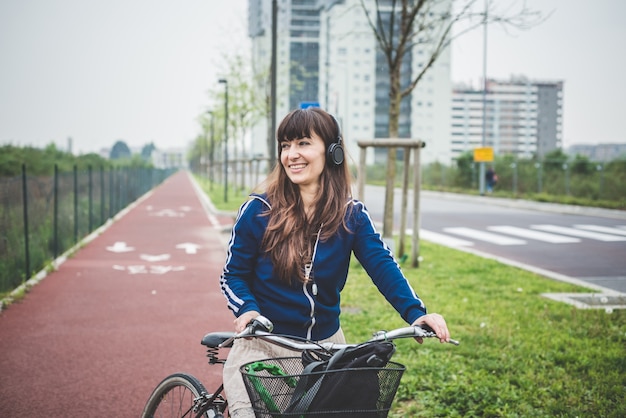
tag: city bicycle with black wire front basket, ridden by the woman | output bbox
[141,316,459,418]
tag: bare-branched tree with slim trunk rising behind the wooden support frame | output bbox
[360,0,542,238]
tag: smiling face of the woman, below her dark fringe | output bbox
[280,132,326,188]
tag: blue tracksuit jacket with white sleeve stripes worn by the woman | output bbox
[220,195,426,341]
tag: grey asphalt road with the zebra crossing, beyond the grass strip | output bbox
[363,186,626,293]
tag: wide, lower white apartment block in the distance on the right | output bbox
[452,77,563,158]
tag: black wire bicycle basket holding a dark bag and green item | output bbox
[240,357,405,418]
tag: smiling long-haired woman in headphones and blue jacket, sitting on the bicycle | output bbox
[220,108,450,417]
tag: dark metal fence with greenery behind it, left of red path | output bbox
[0,165,172,293]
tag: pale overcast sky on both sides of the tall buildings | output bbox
[0,0,626,152]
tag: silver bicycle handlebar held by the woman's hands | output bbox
[219,315,459,351]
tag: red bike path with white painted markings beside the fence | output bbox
[0,171,233,418]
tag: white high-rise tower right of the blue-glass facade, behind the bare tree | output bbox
[320,0,452,162]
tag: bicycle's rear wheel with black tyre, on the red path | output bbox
[141,373,208,418]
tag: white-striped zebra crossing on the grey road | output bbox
[416,224,626,247]
